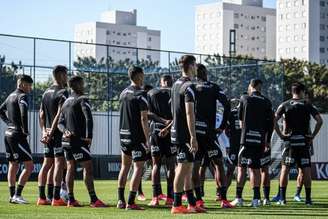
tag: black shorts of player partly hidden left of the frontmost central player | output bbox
[150,133,177,157]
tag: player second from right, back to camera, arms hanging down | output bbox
[232,79,273,207]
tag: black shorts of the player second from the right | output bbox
[238,145,264,169]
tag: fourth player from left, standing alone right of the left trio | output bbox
[117,66,150,210]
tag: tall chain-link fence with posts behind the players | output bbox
[0,34,284,154]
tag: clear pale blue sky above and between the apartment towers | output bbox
[0,0,276,52]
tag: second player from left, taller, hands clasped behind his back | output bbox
[37,65,68,206]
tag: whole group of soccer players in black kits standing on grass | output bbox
[0,55,322,214]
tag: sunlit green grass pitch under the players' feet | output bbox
[0,180,328,219]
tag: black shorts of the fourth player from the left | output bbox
[121,143,149,161]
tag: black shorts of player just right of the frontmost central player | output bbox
[195,136,222,164]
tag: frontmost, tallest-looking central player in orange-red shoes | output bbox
[171,55,205,214]
